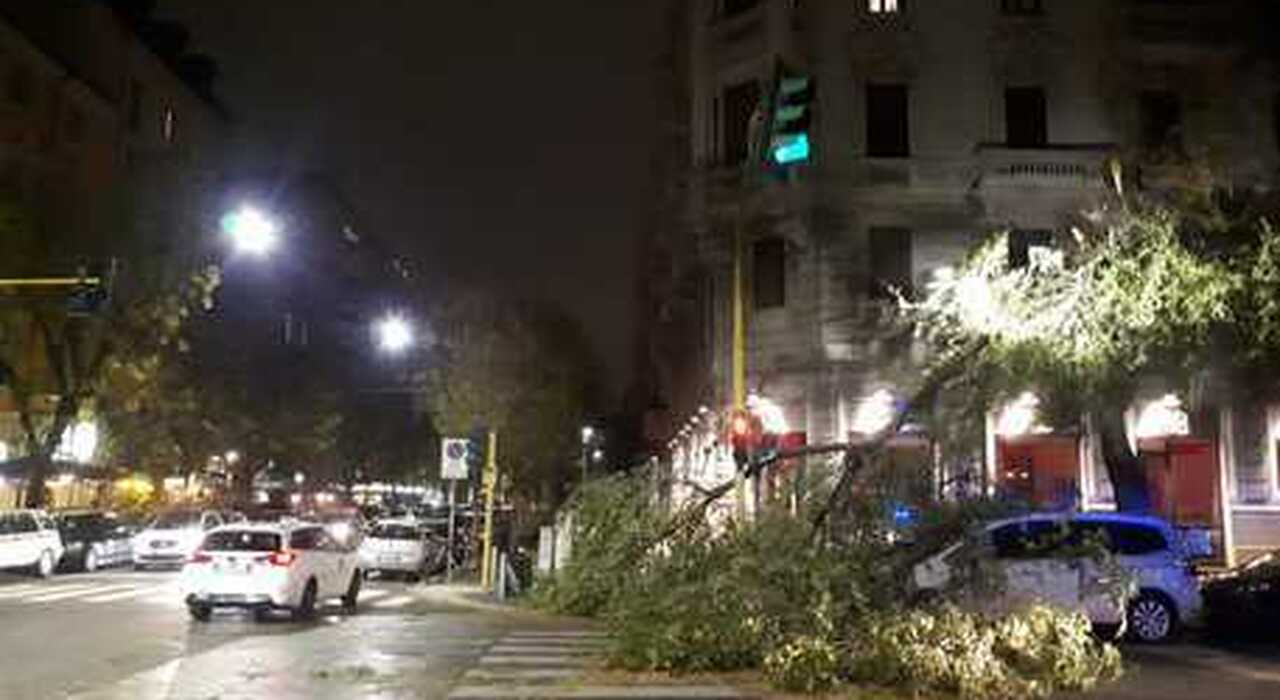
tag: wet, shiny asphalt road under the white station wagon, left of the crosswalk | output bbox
[0,571,524,700]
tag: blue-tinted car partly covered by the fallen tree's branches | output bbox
[913,513,1202,642]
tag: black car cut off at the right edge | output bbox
[1204,552,1280,641]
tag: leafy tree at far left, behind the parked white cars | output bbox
[0,190,220,507]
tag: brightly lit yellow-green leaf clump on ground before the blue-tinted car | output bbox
[849,607,1121,699]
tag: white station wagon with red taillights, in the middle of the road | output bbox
[182,523,362,622]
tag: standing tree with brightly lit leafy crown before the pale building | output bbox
[901,165,1280,511]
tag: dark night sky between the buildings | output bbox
[157,0,657,399]
